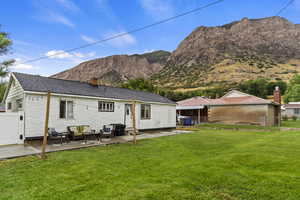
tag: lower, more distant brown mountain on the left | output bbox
[52,51,170,85]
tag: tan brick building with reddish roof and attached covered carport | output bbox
[177,90,281,126]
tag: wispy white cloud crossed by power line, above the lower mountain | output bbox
[104,31,137,47]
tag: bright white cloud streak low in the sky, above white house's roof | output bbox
[45,50,96,59]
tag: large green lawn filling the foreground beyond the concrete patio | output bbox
[0,130,300,200]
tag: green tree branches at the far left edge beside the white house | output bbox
[0,26,14,102]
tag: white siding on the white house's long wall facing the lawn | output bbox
[25,94,176,137]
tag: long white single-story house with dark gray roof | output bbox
[0,73,176,145]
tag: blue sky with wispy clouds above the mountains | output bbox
[0,0,300,76]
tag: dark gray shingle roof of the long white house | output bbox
[13,72,176,104]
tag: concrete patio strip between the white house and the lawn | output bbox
[0,130,191,160]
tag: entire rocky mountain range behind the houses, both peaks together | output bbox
[53,17,300,90]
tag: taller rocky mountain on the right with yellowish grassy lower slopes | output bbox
[152,17,300,88]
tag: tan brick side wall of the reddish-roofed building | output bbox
[208,105,271,125]
